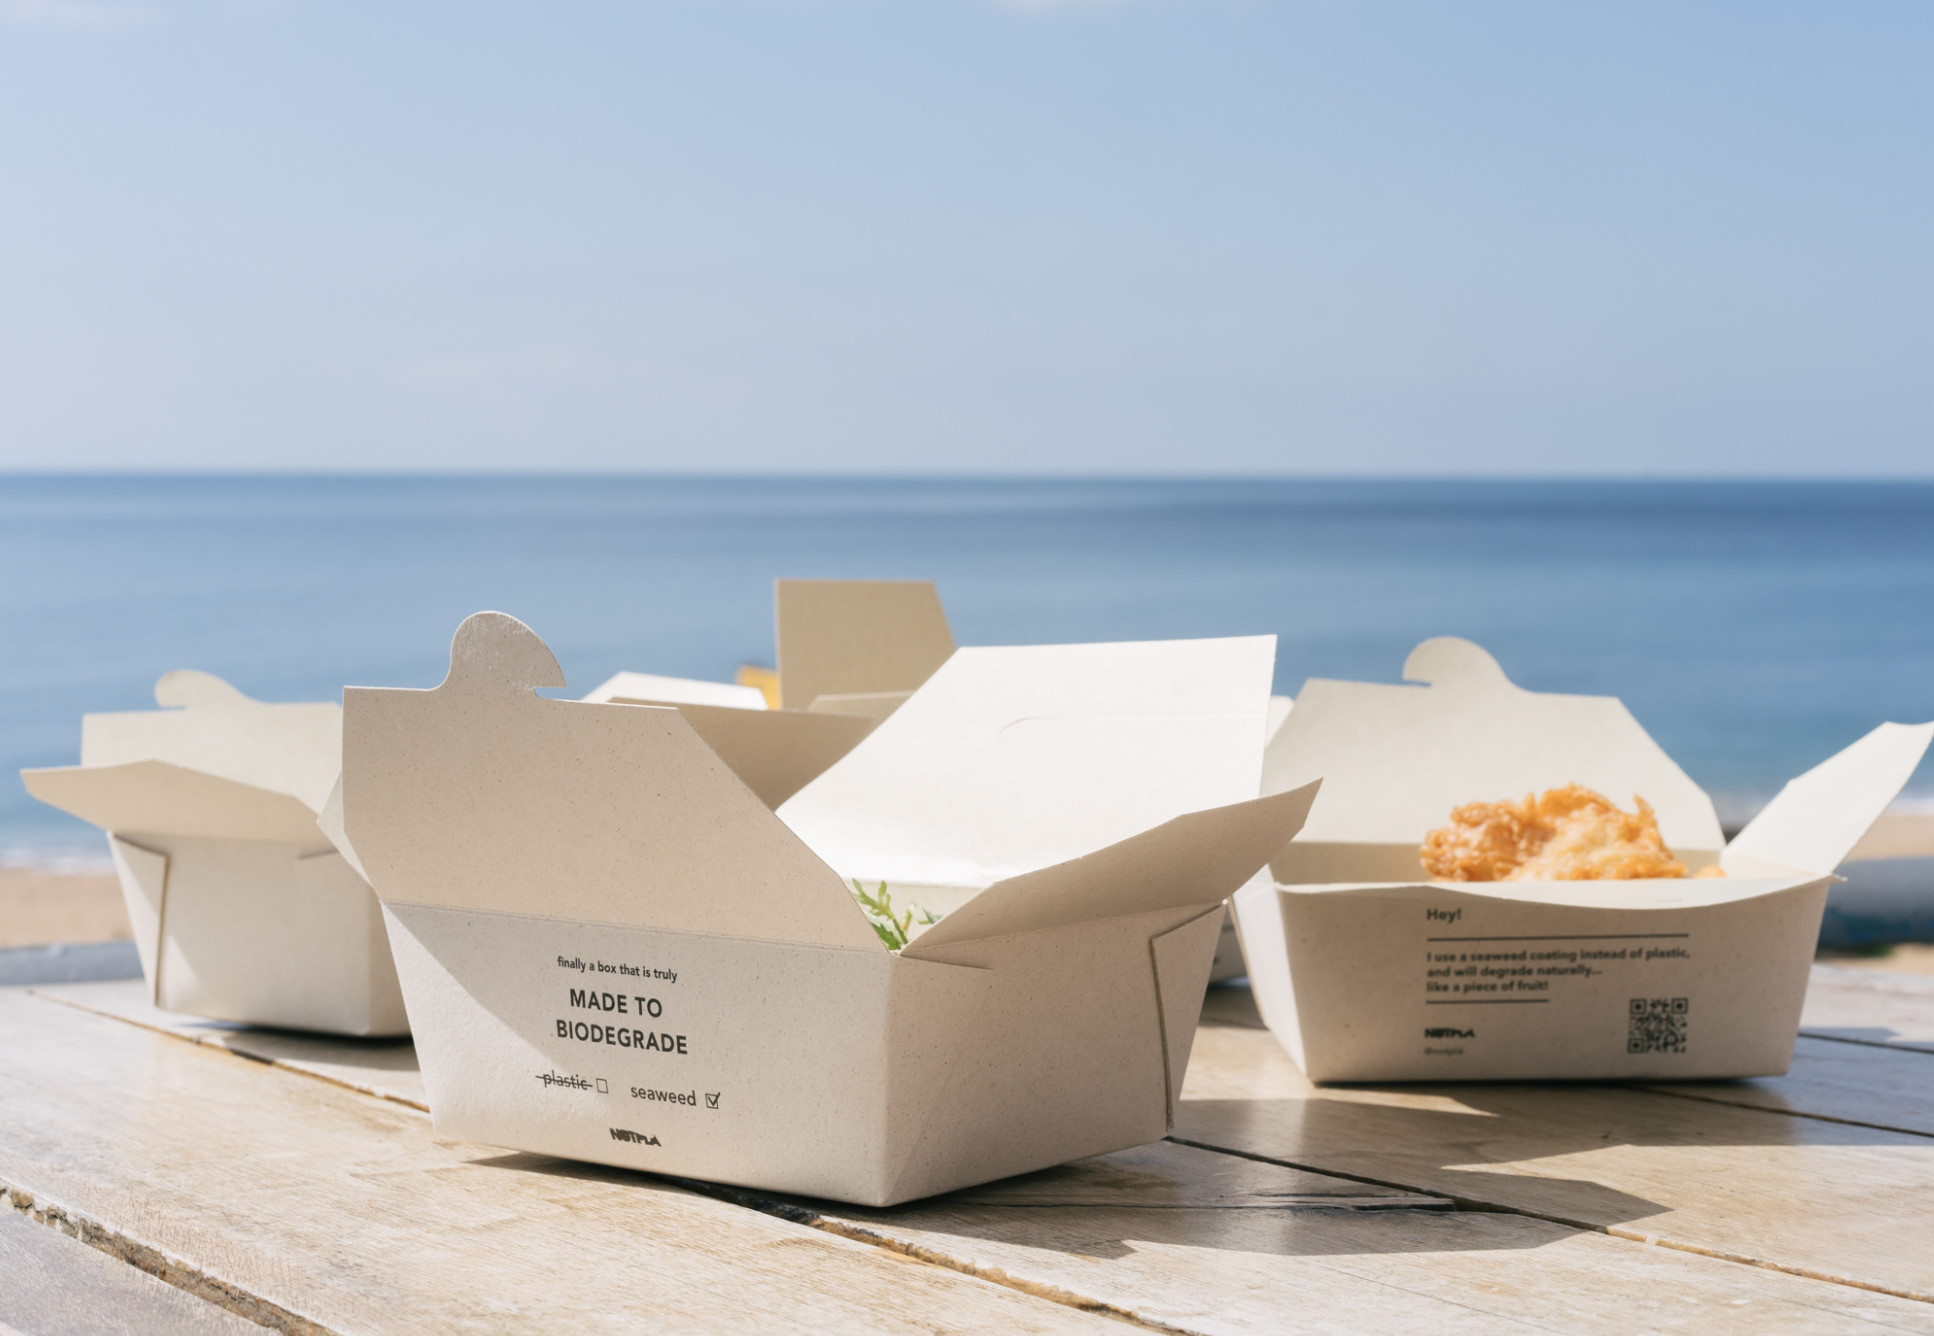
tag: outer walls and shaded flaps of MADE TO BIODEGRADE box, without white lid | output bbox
[342,613,1313,1205]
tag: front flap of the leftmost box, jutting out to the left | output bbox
[19,760,325,845]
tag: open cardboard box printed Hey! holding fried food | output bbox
[1234,638,1934,1081]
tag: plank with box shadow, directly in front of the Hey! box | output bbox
[1176,1025,1934,1299]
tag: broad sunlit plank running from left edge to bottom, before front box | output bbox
[0,992,1116,1332]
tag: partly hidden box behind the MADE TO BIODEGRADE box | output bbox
[584,580,953,806]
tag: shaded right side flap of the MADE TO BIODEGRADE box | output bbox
[901,783,1319,959]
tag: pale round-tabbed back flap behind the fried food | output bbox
[1263,636,1723,855]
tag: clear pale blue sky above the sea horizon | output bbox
[0,0,1934,476]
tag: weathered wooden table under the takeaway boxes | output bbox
[0,967,1934,1336]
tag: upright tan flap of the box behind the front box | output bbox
[774,580,953,710]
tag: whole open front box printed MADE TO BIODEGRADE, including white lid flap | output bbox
[331,613,1313,1205]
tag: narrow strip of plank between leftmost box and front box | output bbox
[33,982,429,1110]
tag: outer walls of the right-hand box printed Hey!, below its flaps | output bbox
[1236,878,1826,1081]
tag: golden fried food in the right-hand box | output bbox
[1423,783,1694,882]
